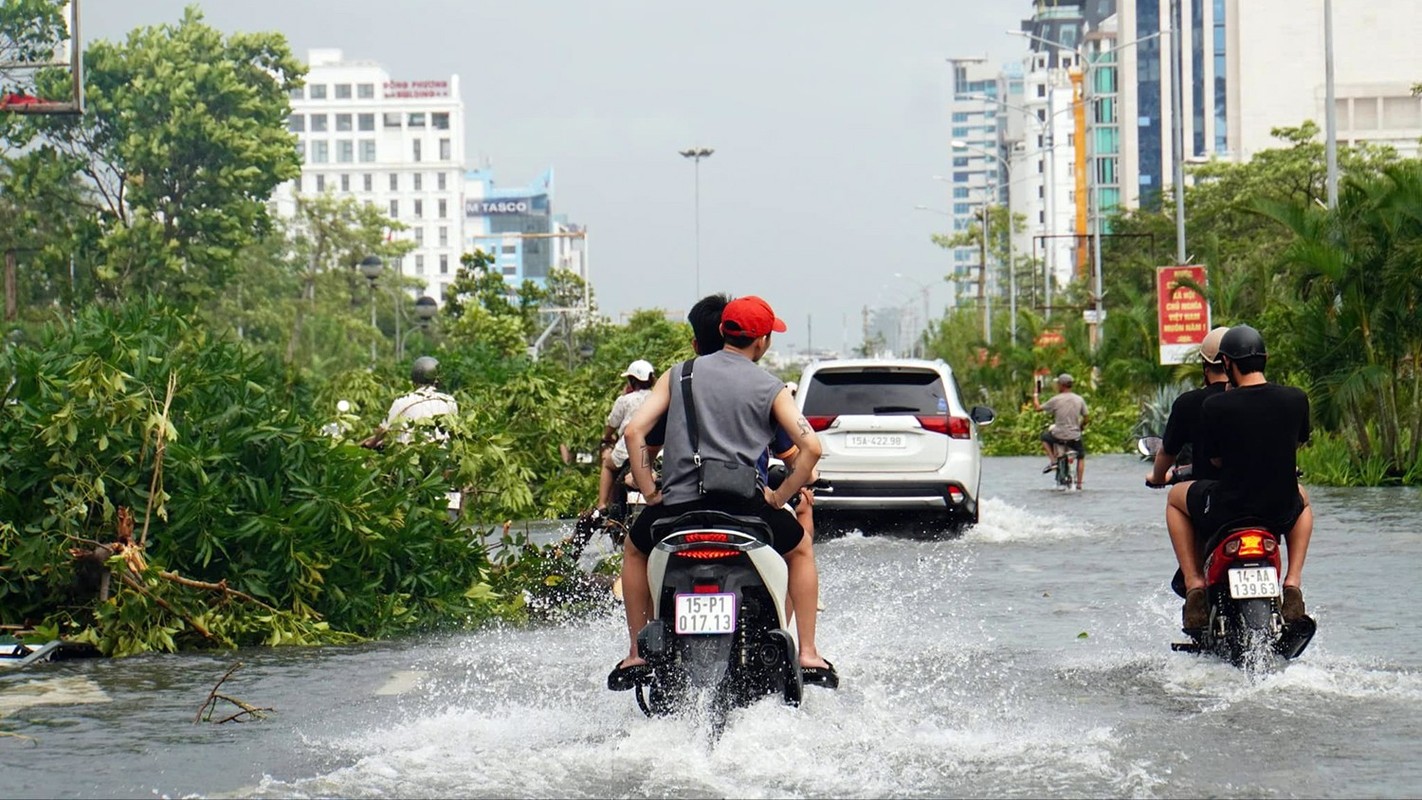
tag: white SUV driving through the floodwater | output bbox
[796,358,995,530]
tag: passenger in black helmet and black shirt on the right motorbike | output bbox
[1166,325,1314,629]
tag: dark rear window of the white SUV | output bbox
[801,369,948,416]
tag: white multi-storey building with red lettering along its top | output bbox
[274,48,465,300]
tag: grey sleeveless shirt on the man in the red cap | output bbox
[661,350,785,504]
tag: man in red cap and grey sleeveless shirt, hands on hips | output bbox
[607,296,839,689]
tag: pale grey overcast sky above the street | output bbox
[82,0,1031,354]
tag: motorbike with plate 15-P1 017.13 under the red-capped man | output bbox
[625,470,829,730]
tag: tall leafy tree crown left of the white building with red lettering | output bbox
[9,7,304,303]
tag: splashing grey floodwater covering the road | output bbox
[0,456,1422,797]
